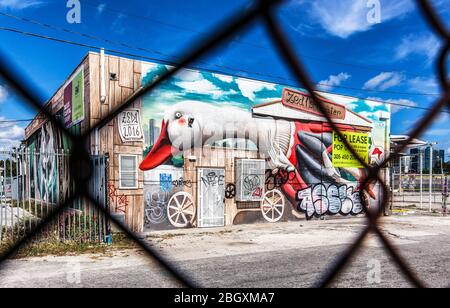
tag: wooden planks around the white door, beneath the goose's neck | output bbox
[184,147,259,226]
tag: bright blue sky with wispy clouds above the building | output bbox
[0,0,450,159]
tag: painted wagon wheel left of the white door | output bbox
[167,192,196,228]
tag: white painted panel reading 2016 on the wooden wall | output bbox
[117,109,144,142]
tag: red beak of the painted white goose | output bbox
[139,120,178,171]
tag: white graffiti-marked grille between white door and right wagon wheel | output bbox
[236,159,266,202]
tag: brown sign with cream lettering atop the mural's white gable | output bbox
[282,89,346,120]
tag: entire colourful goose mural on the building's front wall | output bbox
[140,64,390,229]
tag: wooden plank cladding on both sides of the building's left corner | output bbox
[26,52,144,232]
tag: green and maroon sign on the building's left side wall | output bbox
[64,66,85,127]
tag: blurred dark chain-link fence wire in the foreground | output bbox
[0,0,450,287]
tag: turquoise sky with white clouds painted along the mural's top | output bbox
[142,63,391,146]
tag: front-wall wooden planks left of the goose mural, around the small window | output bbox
[89,53,144,232]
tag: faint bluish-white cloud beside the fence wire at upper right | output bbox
[395,35,440,63]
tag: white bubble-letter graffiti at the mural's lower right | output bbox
[297,184,364,218]
